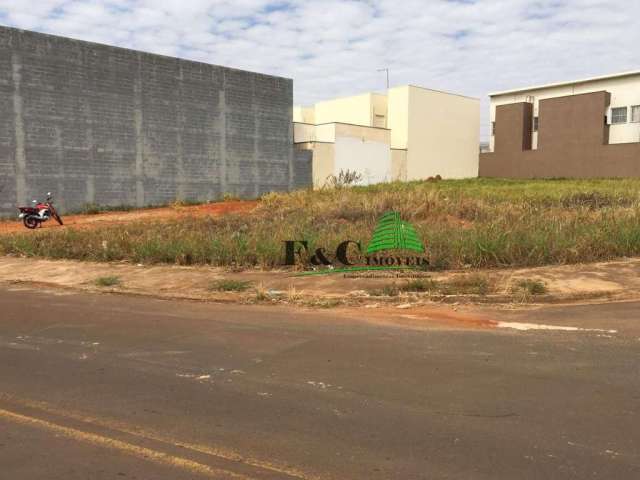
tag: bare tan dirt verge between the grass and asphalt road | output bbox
[0,257,640,314]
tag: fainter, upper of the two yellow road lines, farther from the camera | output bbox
[0,392,322,480]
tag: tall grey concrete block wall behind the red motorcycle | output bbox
[0,27,312,215]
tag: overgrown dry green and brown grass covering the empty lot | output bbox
[0,179,640,269]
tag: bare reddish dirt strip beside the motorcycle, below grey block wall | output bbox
[0,201,258,234]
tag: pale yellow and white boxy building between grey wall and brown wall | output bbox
[293,86,480,187]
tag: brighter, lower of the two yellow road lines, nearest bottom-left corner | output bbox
[0,409,251,480]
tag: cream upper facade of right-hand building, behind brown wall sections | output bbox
[490,71,640,152]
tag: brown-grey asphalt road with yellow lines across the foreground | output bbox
[0,287,640,480]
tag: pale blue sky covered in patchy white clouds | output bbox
[0,0,640,141]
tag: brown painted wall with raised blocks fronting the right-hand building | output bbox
[480,91,640,178]
